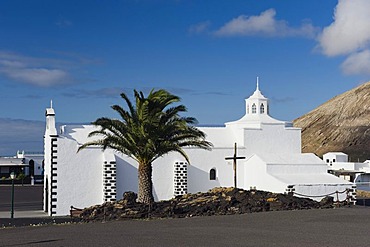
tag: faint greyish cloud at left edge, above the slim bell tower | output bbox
[0,52,69,87]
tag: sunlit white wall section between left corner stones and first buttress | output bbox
[56,138,103,215]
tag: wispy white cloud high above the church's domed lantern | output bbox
[214,9,317,38]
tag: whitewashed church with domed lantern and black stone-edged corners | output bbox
[44,82,354,216]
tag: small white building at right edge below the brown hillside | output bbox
[323,152,370,190]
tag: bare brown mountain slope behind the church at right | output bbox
[293,82,370,161]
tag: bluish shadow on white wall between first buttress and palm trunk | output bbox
[115,155,138,200]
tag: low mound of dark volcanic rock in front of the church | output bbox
[79,188,344,222]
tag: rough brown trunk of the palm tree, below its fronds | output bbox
[137,163,154,205]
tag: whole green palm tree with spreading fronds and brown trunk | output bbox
[78,89,212,204]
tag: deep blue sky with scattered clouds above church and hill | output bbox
[0,0,370,127]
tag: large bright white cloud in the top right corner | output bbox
[318,0,370,56]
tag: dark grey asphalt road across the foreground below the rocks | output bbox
[0,207,370,247]
